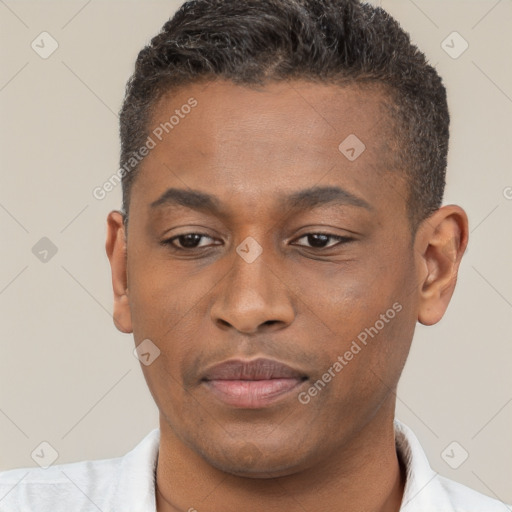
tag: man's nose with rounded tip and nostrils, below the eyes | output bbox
[211,247,295,334]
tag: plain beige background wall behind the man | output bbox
[0,0,512,504]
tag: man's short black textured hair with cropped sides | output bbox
[120,0,450,231]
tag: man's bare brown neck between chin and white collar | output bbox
[156,406,405,512]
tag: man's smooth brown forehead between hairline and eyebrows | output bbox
[133,81,406,222]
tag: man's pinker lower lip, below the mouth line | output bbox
[205,379,304,409]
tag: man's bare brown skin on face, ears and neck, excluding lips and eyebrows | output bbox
[106,80,468,512]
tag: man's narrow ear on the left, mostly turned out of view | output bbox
[105,210,133,333]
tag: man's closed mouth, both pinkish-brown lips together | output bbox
[201,358,308,409]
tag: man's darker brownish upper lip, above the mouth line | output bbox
[202,358,307,381]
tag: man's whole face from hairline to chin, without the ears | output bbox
[119,81,418,476]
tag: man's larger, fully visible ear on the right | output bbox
[415,205,469,325]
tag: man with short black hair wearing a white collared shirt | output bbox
[0,0,507,512]
